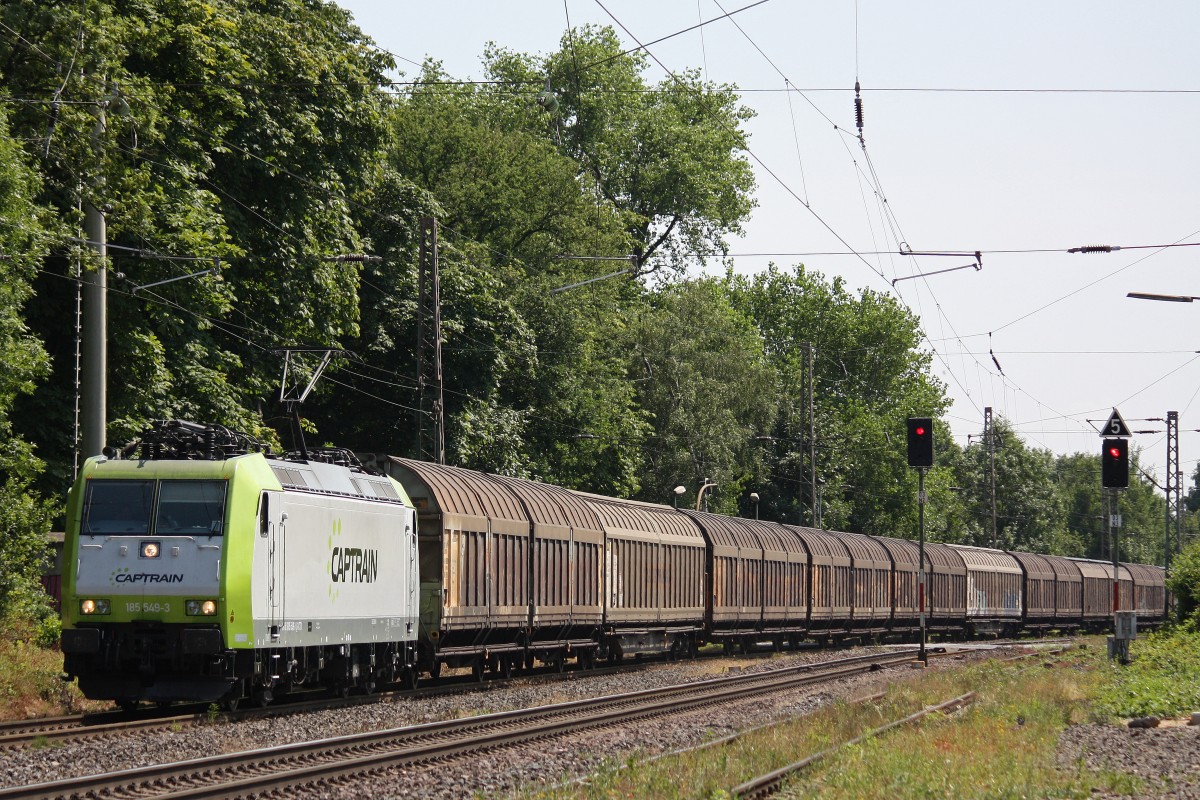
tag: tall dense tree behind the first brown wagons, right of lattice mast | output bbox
[376,64,643,494]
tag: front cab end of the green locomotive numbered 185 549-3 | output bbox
[62,459,233,702]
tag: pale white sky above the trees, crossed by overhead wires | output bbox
[338,0,1200,486]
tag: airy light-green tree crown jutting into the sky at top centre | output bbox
[485,26,754,270]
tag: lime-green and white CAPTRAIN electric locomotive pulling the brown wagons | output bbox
[62,421,419,706]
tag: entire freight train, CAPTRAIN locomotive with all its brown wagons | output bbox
[62,421,1168,706]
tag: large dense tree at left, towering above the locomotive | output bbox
[0,0,390,488]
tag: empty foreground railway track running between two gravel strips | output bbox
[0,652,912,800]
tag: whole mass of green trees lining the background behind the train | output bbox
[0,0,1180,642]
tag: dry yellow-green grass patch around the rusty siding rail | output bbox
[523,643,1161,800]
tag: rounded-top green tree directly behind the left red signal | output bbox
[732,265,958,537]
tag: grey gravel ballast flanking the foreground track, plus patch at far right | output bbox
[0,650,1161,800]
